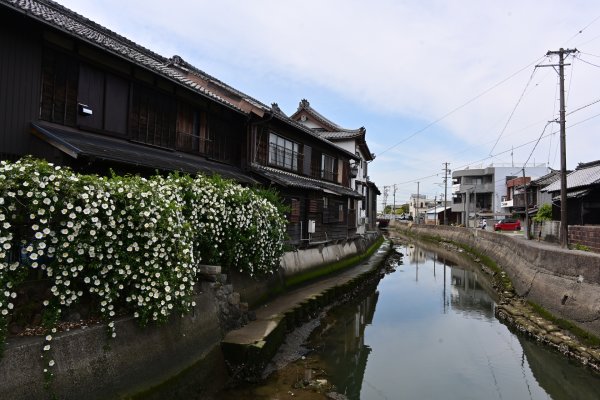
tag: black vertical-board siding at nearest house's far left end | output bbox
[0,11,41,160]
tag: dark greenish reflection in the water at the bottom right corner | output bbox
[517,335,600,400]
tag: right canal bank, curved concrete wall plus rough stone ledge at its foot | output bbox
[391,224,600,372]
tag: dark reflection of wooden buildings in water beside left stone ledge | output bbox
[311,291,379,399]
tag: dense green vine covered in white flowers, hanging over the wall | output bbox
[0,158,286,367]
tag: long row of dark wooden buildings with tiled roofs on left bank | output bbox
[0,0,375,246]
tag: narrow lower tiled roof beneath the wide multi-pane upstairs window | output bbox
[252,164,363,199]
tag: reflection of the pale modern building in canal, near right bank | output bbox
[450,267,494,319]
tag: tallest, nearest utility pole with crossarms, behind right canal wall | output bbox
[544,47,578,249]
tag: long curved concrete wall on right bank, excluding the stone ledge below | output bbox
[390,223,600,336]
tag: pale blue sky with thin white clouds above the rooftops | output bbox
[58,0,600,209]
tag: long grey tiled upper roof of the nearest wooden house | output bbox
[0,0,242,111]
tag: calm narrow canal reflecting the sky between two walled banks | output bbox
[142,244,600,400]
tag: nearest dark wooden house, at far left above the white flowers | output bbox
[0,0,256,184]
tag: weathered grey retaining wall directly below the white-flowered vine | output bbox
[0,282,221,400]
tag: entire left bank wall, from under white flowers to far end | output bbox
[0,234,379,400]
